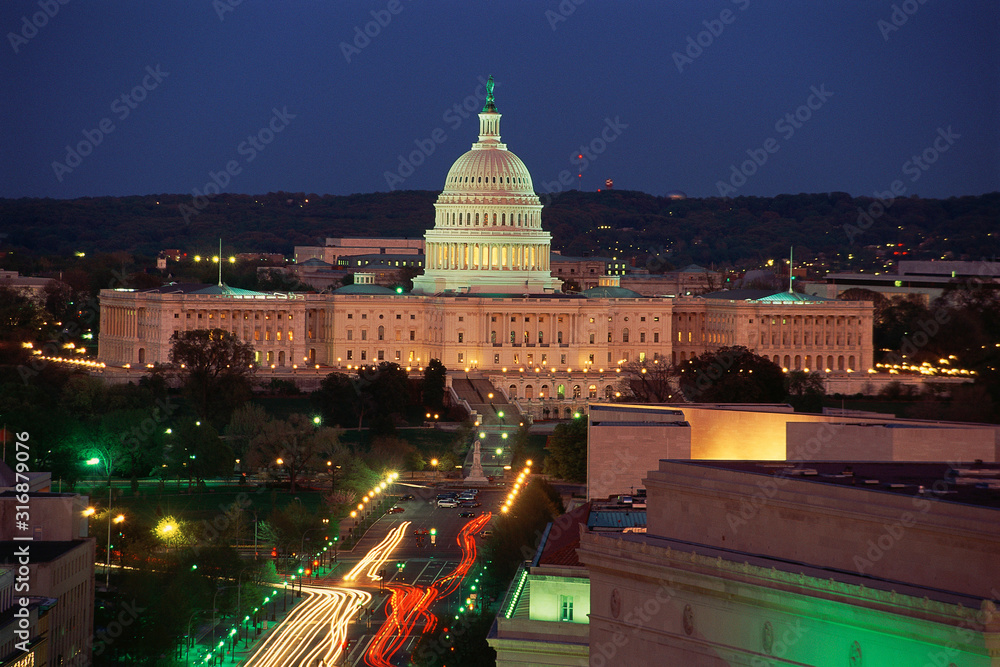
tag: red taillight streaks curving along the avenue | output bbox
[368,512,492,667]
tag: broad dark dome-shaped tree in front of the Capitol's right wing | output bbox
[679,346,785,403]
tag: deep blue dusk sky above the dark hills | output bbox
[0,0,1000,198]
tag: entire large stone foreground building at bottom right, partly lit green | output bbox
[577,461,1000,667]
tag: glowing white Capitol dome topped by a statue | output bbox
[413,77,560,295]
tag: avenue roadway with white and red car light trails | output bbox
[246,486,505,667]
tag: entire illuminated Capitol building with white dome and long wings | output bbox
[99,81,873,417]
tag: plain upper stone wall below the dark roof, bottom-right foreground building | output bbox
[646,461,1000,598]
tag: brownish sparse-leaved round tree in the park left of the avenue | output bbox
[247,414,339,493]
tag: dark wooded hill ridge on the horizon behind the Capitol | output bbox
[0,190,1000,269]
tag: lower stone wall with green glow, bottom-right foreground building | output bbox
[578,533,1000,667]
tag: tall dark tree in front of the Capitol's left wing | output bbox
[170,329,256,419]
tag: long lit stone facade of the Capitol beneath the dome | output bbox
[99,290,871,393]
